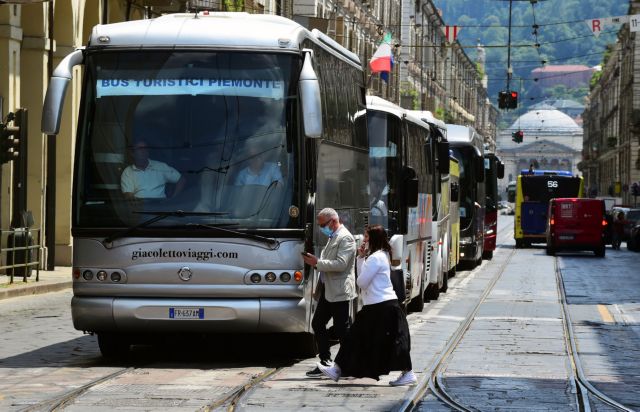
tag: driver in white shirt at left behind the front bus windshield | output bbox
[120,141,185,199]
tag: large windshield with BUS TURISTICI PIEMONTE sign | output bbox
[73,51,300,229]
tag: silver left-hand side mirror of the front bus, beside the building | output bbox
[40,50,84,135]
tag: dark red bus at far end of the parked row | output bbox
[482,148,504,259]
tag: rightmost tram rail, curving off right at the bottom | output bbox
[554,257,634,412]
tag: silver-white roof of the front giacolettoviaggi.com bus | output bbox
[89,12,360,65]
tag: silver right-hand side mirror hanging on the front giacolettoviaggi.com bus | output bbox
[299,49,322,138]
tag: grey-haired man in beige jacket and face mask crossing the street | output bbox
[302,208,357,377]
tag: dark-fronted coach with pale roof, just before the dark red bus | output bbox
[447,124,485,267]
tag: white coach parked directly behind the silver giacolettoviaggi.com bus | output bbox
[367,96,448,311]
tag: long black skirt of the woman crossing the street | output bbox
[335,299,411,380]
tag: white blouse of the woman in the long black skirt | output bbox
[356,250,397,305]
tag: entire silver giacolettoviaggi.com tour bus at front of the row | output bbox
[42,12,369,356]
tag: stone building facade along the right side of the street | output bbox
[579,1,640,206]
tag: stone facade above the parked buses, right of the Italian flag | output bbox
[399,0,498,148]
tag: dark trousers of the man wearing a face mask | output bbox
[311,293,350,361]
